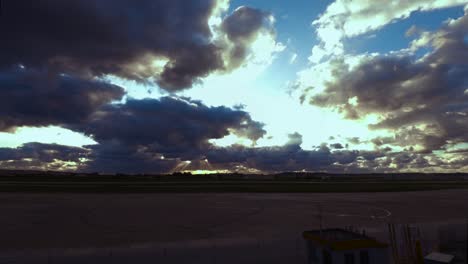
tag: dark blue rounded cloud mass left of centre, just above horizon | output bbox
[68,97,265,172]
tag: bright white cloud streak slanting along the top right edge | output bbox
[310,0,467,62]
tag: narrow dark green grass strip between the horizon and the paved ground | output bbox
[0,179,468,193]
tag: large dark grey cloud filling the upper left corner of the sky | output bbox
[0,0,274,91]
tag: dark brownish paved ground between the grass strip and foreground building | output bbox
[0,190,468,263]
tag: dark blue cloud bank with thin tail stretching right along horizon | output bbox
[71,106,392,173]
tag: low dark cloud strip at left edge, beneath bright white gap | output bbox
[0,143,89,170]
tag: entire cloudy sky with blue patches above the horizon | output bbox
[0,0,468,173]
